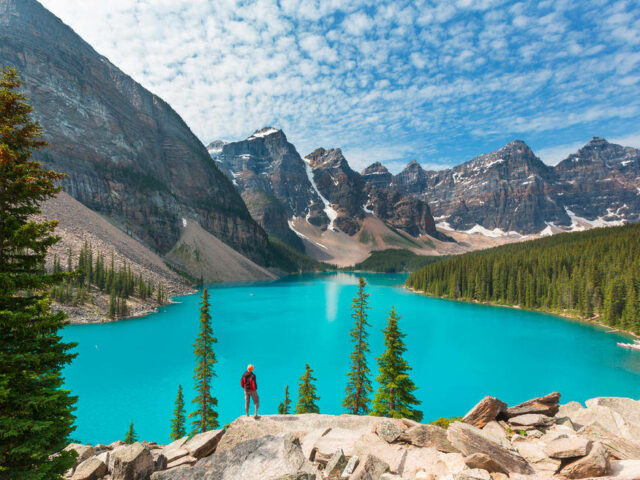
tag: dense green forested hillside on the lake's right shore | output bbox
[407,225,640,333]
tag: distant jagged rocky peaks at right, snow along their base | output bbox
[378,137,640,236]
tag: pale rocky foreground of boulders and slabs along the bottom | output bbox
[62,392,640,480]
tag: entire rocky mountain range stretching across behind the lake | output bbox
[0,0,640,280]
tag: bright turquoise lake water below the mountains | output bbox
[63,273,640,444]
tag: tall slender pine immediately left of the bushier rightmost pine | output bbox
[342,277,371,415]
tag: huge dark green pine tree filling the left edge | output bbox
[0,68,75,480]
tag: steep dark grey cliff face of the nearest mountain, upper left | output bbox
[0,0,268,261]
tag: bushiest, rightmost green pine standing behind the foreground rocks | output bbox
[371,307,422,422]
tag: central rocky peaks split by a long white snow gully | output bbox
[208,127,437,248]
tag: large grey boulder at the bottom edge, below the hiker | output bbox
[191,433,317,480]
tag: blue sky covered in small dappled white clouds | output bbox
[40,0,640,171]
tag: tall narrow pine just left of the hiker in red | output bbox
[189,288,218,434]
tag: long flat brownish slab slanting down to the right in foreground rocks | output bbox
[447,422,533,474]
